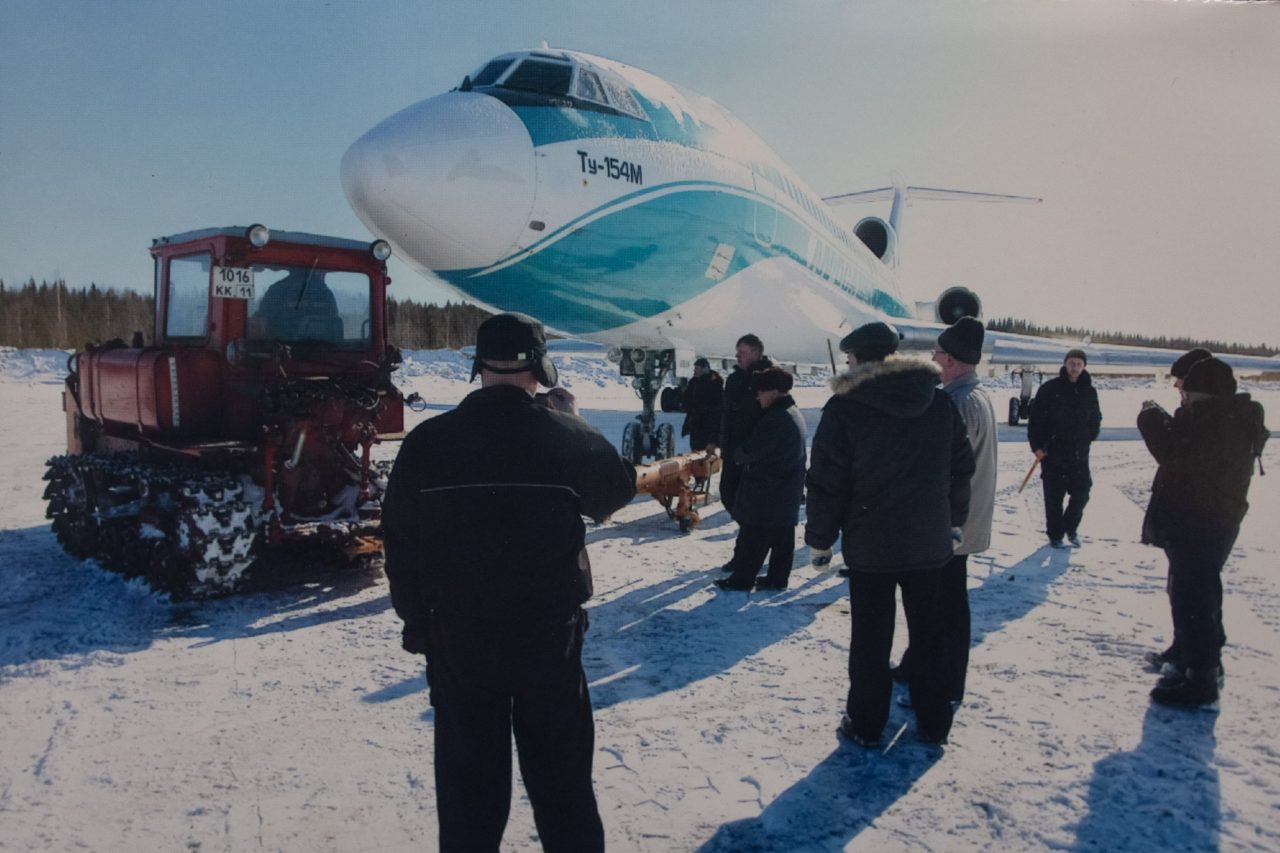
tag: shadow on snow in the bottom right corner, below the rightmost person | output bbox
[1073,704,1221,850]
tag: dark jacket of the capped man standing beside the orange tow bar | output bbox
[733,394,805,528]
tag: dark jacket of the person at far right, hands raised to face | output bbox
[1138,393,1270,547]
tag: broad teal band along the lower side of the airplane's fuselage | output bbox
[438,184,908,334]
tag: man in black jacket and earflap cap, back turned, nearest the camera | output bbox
[383,314,635,850]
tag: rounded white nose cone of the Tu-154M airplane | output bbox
[342,92,536,270]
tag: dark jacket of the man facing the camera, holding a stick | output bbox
[1027,368,1102,476]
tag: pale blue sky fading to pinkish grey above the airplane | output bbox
[0,0,1280,345]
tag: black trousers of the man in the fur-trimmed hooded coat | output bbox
[845,566,952,739]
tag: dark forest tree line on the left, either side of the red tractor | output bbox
[0,279,489,350]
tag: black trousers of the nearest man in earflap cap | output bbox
[430,610,604,852]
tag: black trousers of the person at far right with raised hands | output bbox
[1165,528,1239,670]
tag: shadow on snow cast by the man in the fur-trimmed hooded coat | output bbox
[699,744,942,853]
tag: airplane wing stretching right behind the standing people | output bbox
[892,319,1280,371]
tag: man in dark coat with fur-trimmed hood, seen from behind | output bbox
[805,323,974,747]
